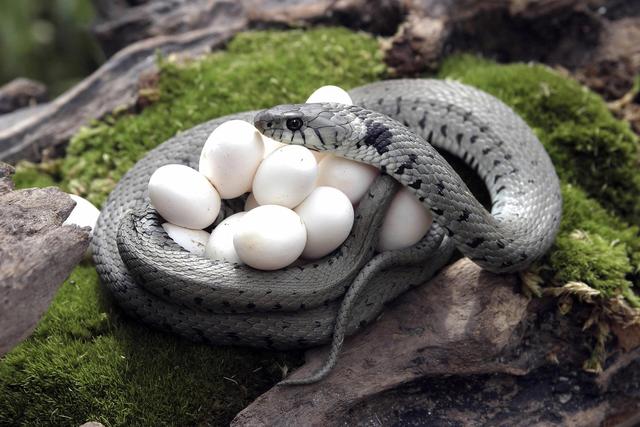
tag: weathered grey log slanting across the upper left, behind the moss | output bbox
[0,22,244,162]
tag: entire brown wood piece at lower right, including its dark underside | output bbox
[232,259,640,427]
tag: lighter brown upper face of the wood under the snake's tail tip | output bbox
[232,259,528,426]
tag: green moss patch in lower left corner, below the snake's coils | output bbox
[0,264,286,425]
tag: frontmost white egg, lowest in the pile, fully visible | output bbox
[233,205,307,270]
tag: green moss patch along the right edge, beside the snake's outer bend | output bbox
[440,55,640,306]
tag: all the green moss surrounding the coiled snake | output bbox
[5,29,640,425]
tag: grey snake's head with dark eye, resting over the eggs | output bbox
[254,103,366,153]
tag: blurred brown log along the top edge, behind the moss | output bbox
[92,0,404,55]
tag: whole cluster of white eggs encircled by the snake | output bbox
[148,86,431,270]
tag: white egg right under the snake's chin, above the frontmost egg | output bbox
[253,145,318,208]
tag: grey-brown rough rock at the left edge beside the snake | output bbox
[0,163,89,356]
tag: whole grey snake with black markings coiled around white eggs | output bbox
[92,79,562,385]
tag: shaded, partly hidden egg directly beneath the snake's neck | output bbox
[317,154,380,205]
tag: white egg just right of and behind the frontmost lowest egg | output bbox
[295,187,353,259]
